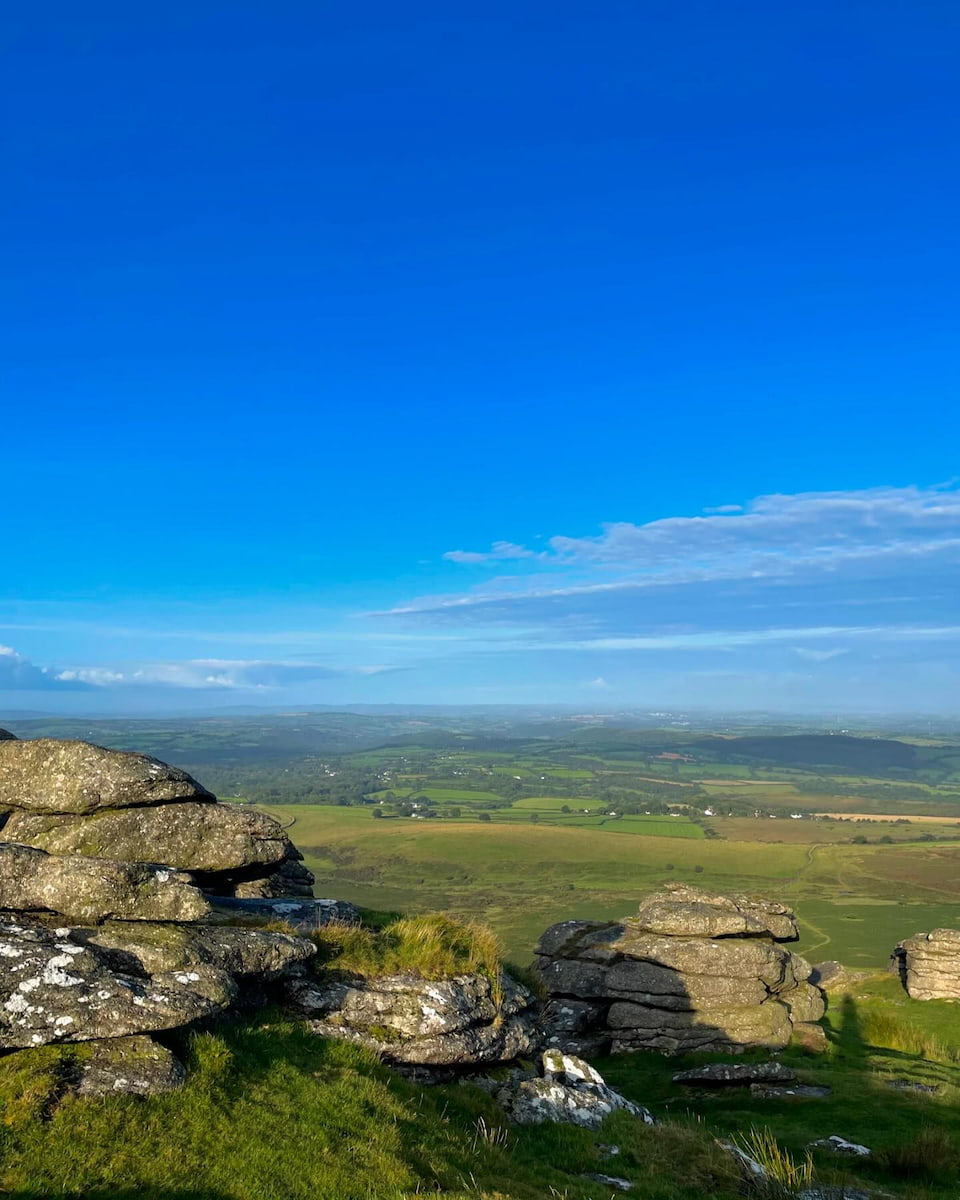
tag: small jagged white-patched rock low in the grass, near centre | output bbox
[494,1050,654,1129]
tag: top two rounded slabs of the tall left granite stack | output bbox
[0,738,313,902]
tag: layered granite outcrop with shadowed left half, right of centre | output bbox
[536,886,824,1054]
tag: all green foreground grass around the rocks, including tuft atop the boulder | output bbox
[0,964,960,1200]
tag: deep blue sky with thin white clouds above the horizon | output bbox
[0,0,960,715]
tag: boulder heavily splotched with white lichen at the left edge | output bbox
[0,924,235,1050]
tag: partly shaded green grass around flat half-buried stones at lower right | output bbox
[596,976,960,1200]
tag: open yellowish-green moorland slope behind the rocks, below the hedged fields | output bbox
[269,805,960,967]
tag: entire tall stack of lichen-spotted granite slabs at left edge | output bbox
[0,737,316,1094]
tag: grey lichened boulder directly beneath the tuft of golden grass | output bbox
[287,974,538,1068]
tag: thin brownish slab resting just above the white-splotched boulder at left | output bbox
[71,920,317,983]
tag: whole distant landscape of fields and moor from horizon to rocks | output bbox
[8,709,960,967]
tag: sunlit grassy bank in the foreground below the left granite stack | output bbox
[0,1013,737,1200]
